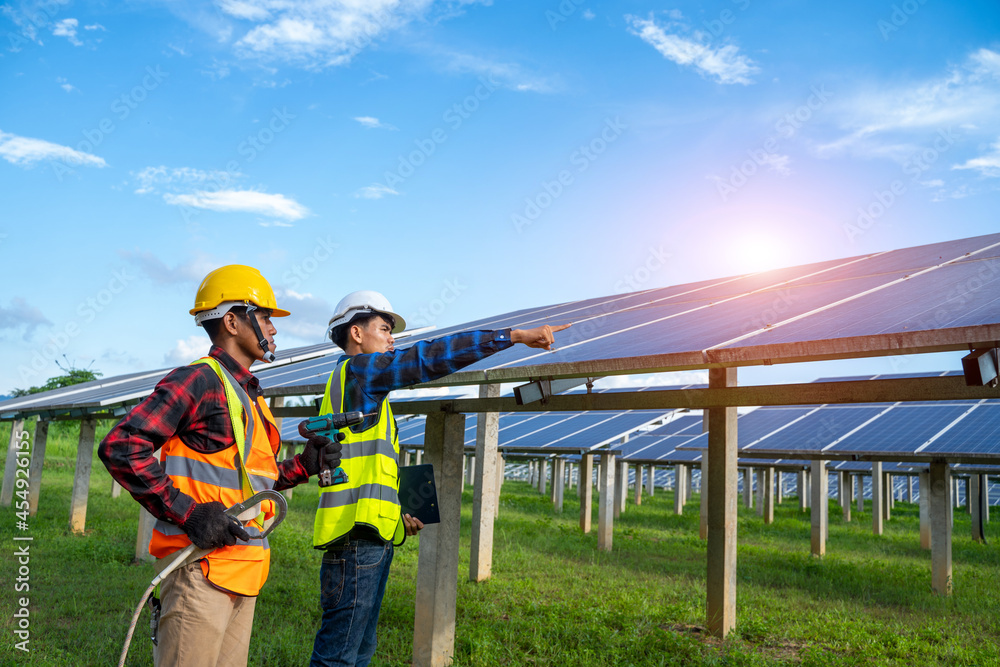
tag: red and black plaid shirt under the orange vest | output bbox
[97,345,309,524]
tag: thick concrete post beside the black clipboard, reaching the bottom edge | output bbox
[412,412,465,667]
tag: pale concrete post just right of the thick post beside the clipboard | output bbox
[469,384,502,581]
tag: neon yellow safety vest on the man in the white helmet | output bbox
[313,359,403,548]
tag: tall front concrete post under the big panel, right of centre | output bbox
[702,368,738,638]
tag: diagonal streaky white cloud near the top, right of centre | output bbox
[625,13,760,85]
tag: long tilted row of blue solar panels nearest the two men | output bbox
[0,234,1000,418]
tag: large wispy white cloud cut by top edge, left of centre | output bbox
[227,0,434,68]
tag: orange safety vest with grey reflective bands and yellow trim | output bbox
[149,357,281,595]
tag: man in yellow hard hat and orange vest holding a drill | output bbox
[98,265,341,666]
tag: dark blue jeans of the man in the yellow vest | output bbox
[309,539,392,667]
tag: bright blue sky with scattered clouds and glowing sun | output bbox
[0,0,1000,393]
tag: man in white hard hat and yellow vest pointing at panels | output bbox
[310,290,569,667]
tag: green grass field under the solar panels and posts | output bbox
[0,424,1000,666]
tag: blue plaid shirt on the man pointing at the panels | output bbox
[341,329,513,433]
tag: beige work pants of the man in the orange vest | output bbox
[153,563,257,667]
